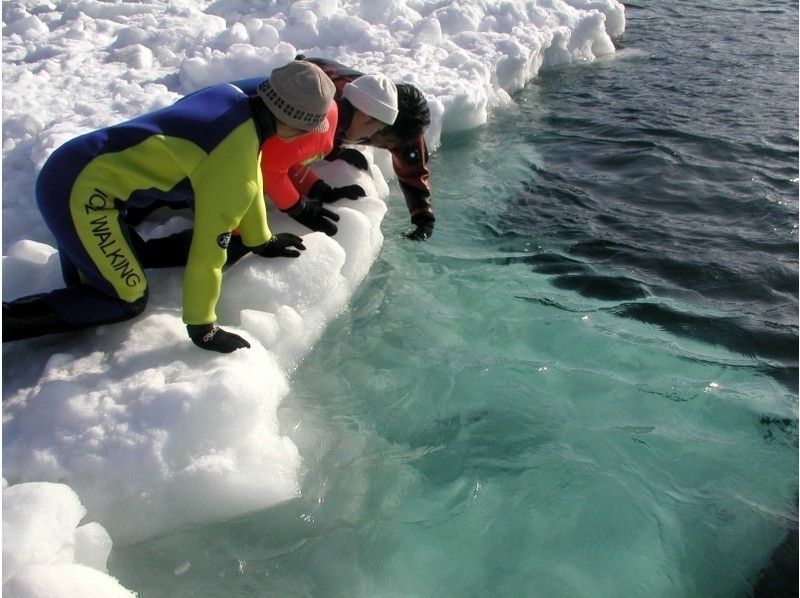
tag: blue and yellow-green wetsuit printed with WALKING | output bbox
[36,84,272,324]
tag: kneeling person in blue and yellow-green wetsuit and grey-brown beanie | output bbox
[3,61,336,353]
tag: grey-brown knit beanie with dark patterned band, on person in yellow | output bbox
[257,60,336,133]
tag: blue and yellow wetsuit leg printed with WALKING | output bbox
[3,143,148,341]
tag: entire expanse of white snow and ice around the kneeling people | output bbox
[2,0,625,596]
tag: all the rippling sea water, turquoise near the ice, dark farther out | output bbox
[110,2,798,596]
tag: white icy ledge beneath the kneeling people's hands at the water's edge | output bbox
[3,163,387,546]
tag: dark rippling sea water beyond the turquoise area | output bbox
[504,2,798,391]
